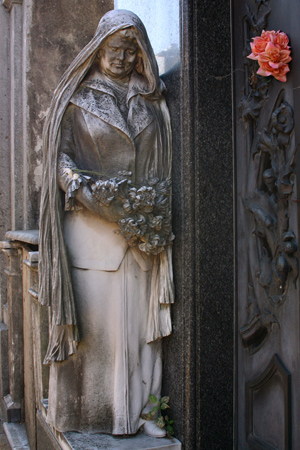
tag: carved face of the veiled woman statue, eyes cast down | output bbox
[99,32,138,80]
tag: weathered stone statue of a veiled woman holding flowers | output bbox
[39,10,173,437]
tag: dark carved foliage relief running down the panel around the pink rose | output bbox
[240,1,298,354]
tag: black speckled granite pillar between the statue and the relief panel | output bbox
[163,0,234,450]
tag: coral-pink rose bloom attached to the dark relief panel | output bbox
[247,30,292,82]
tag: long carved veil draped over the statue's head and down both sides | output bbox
[39,10,174,364]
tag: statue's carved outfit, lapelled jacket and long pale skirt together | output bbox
[47,75,170,434]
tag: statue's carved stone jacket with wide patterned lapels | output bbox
[61,80,162,271]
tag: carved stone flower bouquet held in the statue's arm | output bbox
[91,178,174,255]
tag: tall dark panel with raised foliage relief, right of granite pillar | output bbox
[233,0,300,450]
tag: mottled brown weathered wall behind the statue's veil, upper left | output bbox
[24,0,113,228]
